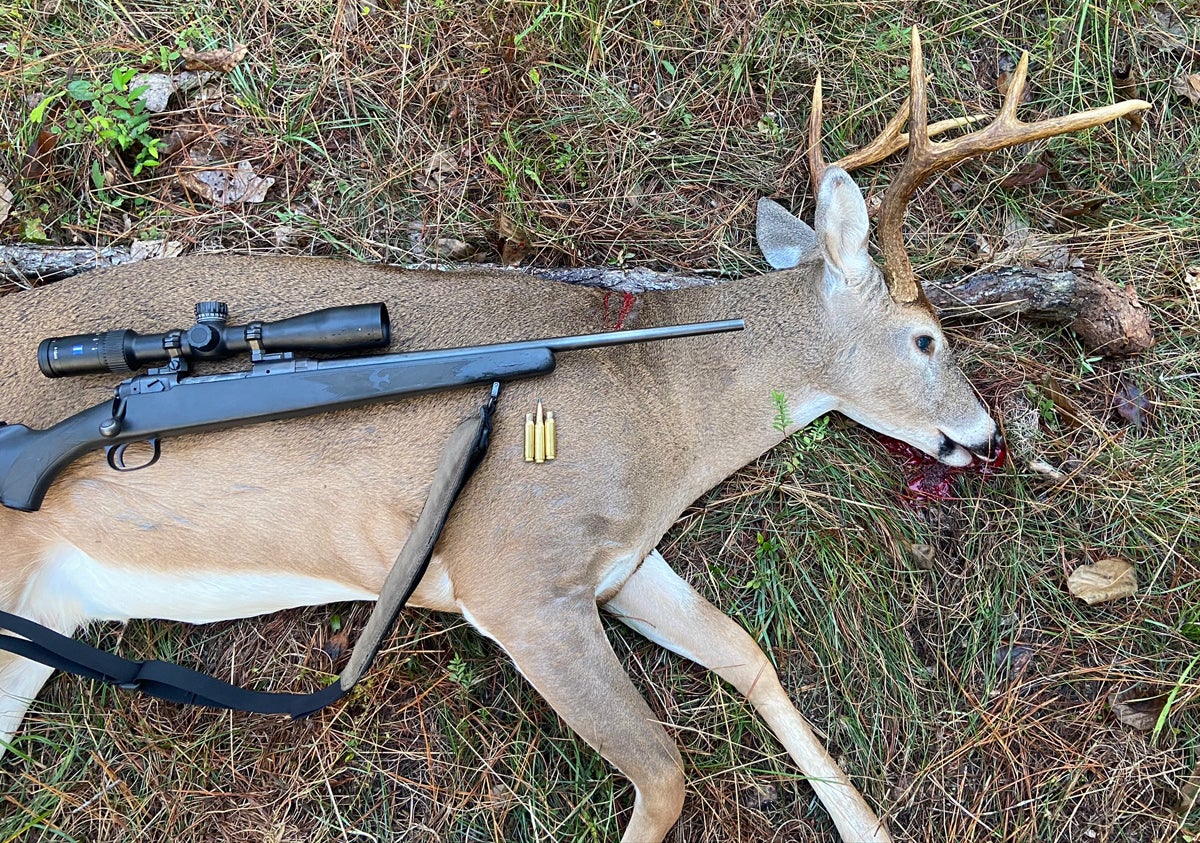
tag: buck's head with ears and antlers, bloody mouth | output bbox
[757,26,1150,466]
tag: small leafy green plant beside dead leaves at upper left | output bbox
[29,67,161,181]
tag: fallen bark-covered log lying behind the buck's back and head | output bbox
[0,245,1153,355]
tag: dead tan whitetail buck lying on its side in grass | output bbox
[0,29,1145,841]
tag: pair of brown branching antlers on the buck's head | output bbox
[809,26,1150,303]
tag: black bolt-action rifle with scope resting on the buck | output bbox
[0,301,744,512]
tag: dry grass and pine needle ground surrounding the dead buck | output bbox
[0,0,1200,843]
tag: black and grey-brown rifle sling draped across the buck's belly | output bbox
[0,383,499,718]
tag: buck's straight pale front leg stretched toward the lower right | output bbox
[605,551,890,843]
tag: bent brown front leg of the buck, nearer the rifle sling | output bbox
[461,592,684,843]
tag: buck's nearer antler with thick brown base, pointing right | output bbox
[878,26,1150,301]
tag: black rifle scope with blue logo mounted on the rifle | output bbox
[37,301,391,377]
